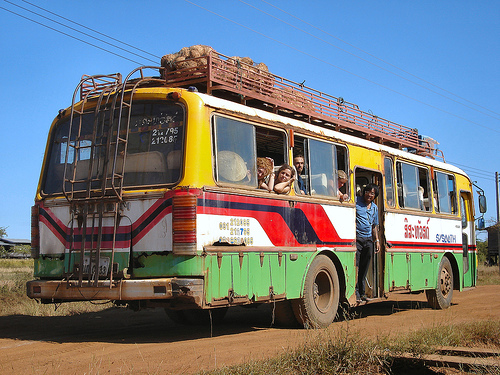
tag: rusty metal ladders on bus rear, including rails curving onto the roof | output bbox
[63,66,164,288]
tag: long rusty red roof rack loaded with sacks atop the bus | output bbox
[162,50,444,161]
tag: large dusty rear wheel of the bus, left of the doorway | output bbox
[292,255,340,328]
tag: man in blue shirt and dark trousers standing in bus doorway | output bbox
[356,184,380,302]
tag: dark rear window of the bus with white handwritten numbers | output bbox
[42,101,185,194]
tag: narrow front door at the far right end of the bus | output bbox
[460,191,476,287]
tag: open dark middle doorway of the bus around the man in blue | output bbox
[354,168,385,298]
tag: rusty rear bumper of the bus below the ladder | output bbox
[26,278,203,305]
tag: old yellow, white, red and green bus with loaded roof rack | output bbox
[27,50,485,327]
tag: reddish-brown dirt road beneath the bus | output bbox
[0,286,500,374]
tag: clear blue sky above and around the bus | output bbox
[0,0,500,238]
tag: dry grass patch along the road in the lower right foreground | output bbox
[201,322,500,375]
